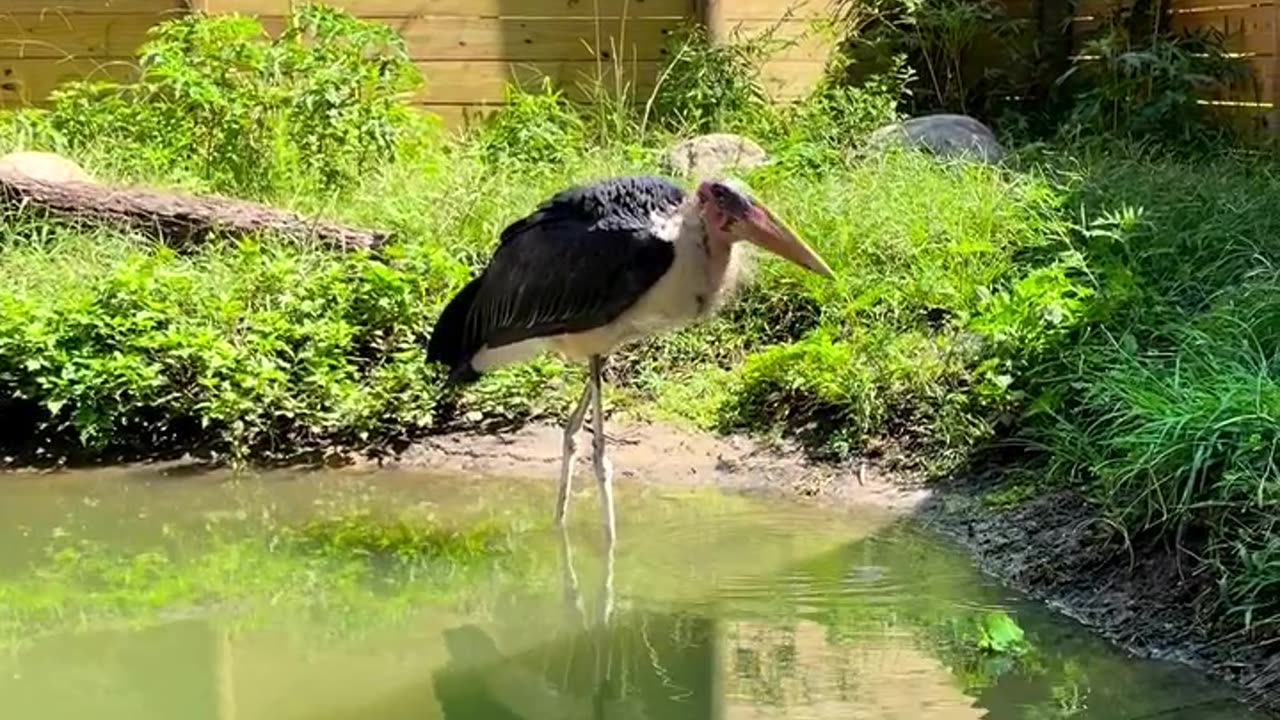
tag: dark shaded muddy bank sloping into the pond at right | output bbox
[916,478,1280,717]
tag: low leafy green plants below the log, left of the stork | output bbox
[0,229,451,455]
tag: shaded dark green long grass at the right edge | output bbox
[1020,149,1280,635]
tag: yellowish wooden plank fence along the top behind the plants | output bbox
[0,0,1280,124]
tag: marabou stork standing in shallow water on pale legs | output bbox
[428,176,832,547]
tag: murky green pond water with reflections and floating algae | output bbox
[0,461,1261,720]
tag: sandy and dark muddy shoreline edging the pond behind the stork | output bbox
[378,421,1280,717]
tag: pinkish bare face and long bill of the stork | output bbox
[698,181,833,278]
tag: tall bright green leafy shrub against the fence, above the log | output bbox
[36,4,421,195]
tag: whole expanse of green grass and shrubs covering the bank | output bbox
[0,1,1280,655]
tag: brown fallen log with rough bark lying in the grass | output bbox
[0,168,390,251]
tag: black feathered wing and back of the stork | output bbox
[428,176,685,382]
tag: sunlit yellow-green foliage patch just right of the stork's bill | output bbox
[721,154,1088,466]
